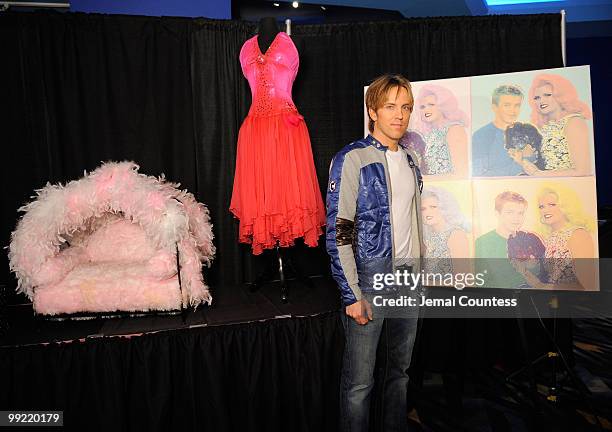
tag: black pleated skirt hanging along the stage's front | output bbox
[0,313,344,432]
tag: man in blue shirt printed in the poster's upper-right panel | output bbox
[472,85,523,177]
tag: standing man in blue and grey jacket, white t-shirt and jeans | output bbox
[326,75,423,431]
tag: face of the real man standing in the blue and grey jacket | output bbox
[368,87,413,144]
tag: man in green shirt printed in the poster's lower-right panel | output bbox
[476,191,544,288]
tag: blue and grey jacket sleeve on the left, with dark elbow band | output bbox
[326,151,361,306]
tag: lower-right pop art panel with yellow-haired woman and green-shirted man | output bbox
[472,177,599,291]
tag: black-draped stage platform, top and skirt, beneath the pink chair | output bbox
[0,278,344,431]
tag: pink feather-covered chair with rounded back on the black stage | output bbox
[9,162,215,316]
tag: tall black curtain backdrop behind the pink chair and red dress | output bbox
[0,13,562,295]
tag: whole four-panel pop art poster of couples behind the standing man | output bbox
[364,66,599,290]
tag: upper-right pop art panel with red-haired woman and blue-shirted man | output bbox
[471,66,595,177]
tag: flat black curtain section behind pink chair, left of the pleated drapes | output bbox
[0,13,201,296]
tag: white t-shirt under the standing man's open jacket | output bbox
[385,149,416,259]
